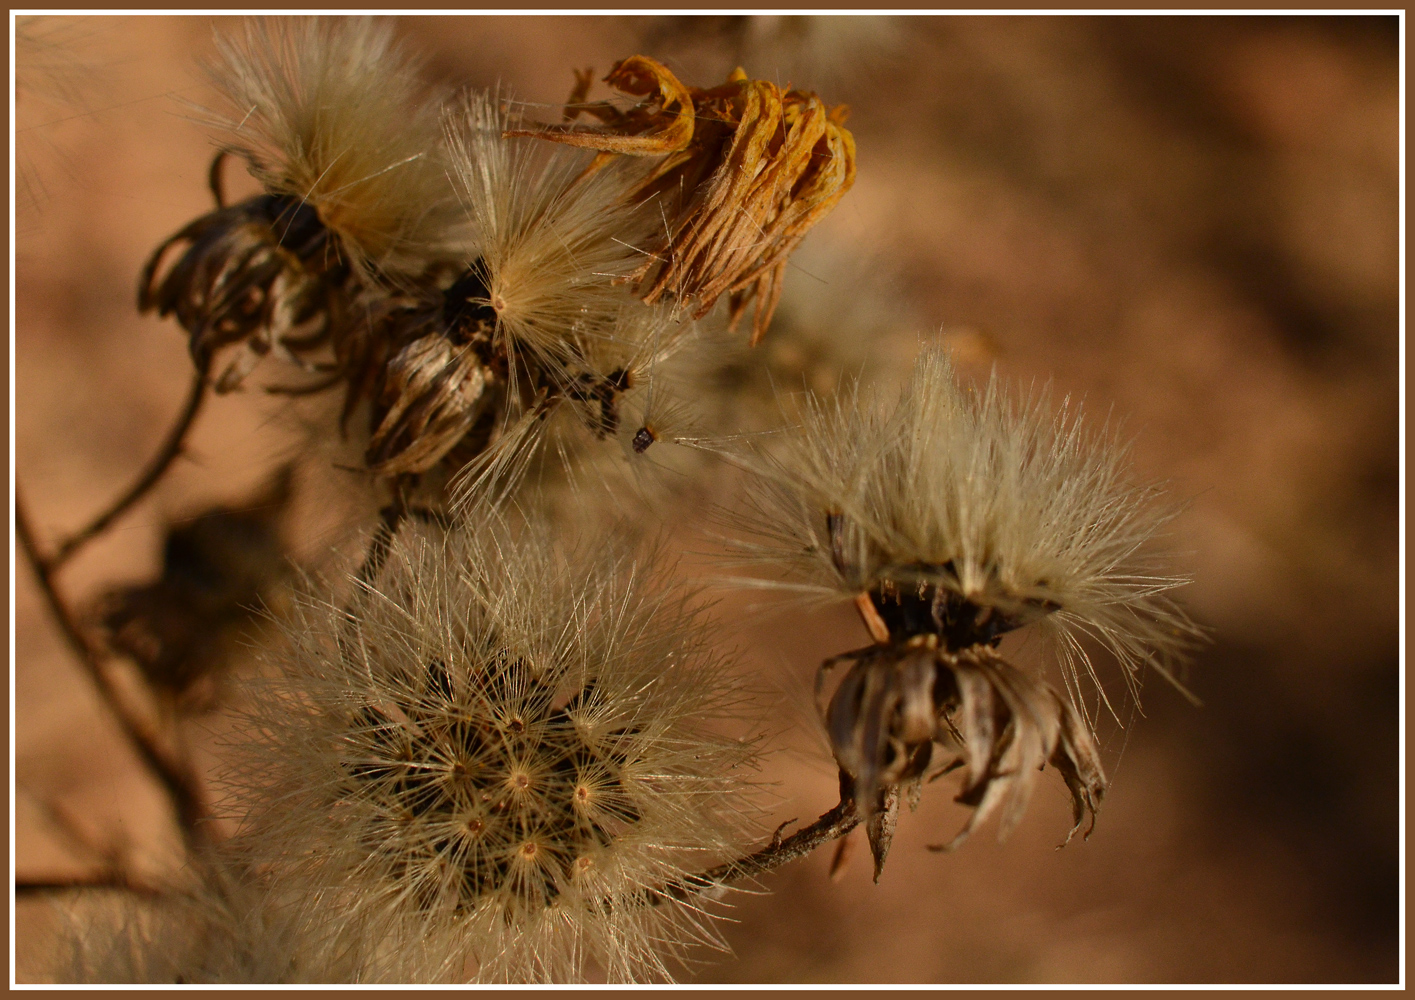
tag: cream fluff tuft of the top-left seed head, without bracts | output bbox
[209,17,456,280]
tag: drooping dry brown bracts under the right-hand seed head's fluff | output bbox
[818,635,1107,878]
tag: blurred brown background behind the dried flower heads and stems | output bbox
[16,17,1399,982]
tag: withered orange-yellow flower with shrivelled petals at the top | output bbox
[508,55,855,344]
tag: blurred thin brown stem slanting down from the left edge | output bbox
[14,485,207,847]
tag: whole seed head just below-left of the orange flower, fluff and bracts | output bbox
[368,95,691,475]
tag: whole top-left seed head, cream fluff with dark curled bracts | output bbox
[139,18,453,390]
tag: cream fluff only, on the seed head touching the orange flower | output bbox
[444,93,686,389]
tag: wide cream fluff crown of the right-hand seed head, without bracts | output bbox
[733,349,1201,713]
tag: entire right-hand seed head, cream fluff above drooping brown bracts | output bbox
[724,351,1199,874]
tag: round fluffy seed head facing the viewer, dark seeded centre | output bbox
[233,523,760,982]
